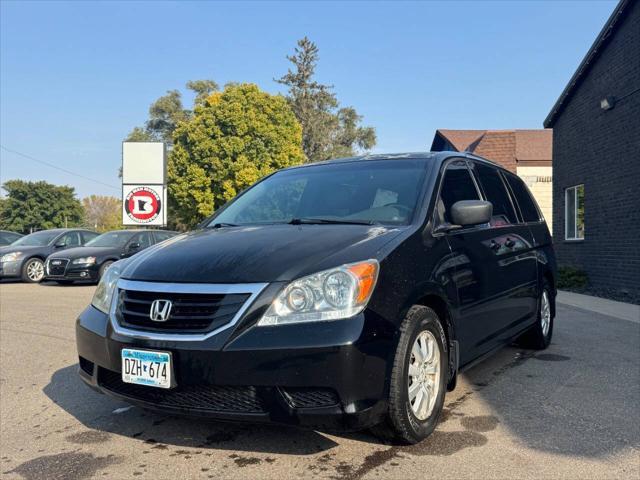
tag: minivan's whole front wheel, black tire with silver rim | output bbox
[372,305,449,444]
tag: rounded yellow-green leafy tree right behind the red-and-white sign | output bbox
[168,84,304,227]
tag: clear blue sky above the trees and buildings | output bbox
[0,0,616,198]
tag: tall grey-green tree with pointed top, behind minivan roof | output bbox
[276,37,376,162]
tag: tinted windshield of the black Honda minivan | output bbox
[209,159,426,226]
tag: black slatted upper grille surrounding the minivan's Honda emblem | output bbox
[117,290,250,333]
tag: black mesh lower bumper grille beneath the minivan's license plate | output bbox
[98,368,265,413]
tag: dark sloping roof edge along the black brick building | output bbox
[543,0,636,128]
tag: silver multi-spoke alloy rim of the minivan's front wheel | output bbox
[407,330,440,421]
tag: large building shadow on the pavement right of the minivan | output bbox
[456,306,640,457]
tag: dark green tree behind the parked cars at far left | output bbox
[0,180,83,233]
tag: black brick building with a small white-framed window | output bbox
[544,0,640,302]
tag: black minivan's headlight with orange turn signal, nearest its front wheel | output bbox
[258,260,379,326]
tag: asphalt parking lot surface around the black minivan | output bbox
[0,283,640,480]
